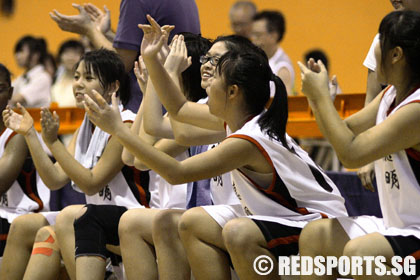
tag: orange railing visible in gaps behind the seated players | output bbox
[23,93,365,138]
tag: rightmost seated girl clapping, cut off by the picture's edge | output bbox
[299,11,420,279]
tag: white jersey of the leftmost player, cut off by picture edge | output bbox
[0,128,50,223]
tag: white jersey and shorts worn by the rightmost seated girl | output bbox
[338,86,420,278]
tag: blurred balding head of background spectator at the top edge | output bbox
[229,1,257,39]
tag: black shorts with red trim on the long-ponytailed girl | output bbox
[252,219,302,257]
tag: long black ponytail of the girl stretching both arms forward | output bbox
[258,73,289,149]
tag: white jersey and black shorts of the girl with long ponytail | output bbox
[227,116,347,256]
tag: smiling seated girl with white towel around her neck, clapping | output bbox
[2,50,149,279]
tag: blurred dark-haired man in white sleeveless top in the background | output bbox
[251,11,295,95]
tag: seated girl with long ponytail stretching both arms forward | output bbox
[86,17,347,279]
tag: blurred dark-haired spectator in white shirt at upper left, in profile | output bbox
[10,36,52,107]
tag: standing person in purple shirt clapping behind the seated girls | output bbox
[50,0,200,112]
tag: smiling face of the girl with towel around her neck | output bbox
[73,60,106,108]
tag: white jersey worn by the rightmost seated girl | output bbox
[375,86,420,228]
